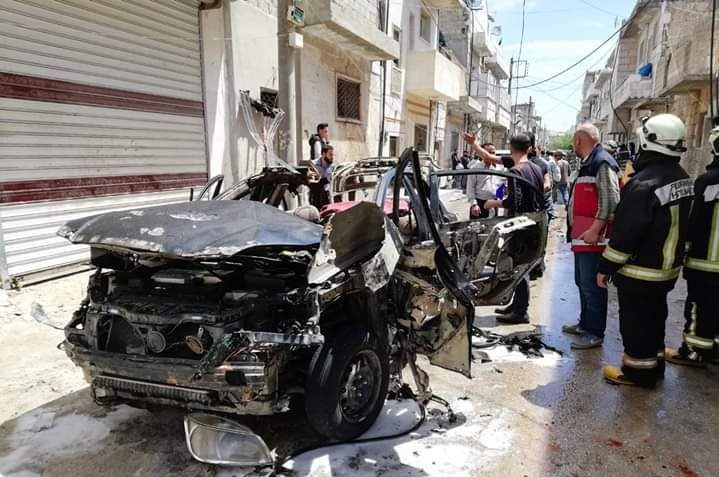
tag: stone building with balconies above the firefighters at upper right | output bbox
[577,0,719,175]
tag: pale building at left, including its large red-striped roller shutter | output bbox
[0,0,399,287]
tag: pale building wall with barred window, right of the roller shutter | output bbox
[204,0,399,181]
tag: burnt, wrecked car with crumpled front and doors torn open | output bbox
[58,149,547,452]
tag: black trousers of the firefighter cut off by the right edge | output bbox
[682,278,719,358]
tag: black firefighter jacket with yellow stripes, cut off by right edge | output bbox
[684,159,719,284]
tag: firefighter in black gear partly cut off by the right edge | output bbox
[667,127,719,367]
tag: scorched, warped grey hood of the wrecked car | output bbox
[58,200,322,259]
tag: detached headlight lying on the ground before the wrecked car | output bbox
[185,413,273,467]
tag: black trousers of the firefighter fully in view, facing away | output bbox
[614,275,674,386]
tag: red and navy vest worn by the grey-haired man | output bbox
[568,145,619,252]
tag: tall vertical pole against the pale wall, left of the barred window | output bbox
[277,0,302,166]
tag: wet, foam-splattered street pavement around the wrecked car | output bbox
[0,208,719,477]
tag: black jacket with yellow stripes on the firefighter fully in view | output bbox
[599,153,694,286]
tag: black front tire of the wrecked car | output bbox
[305,326,389,441]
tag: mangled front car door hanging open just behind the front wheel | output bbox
[382,148,474,377]
